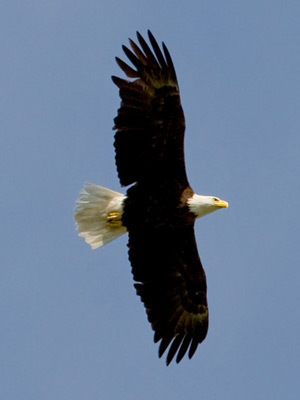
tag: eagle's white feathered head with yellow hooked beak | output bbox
[187,193,229,218]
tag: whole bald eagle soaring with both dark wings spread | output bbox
[75,31,228,365]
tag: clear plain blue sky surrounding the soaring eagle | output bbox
[0,0,300,400]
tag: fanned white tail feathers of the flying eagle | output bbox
[75,183,126,249]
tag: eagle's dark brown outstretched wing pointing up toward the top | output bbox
[112,31,187,186]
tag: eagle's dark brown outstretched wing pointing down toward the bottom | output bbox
[129,223,208,365]
